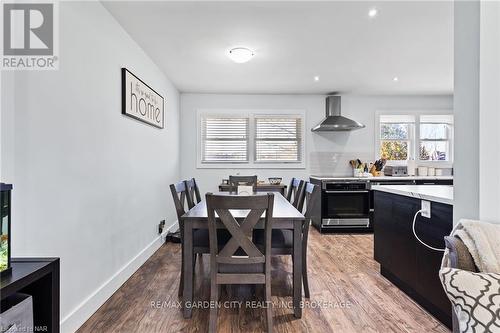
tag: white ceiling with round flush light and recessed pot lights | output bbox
[104,1,453,94]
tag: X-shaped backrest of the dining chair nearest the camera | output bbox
[206,193,274,265]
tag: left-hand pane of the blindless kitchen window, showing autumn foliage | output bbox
[380,115,415,161]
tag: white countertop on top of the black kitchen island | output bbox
[372,185,453,205]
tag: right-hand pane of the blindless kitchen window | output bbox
[419,115,453,161]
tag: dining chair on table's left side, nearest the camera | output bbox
[170,178,229,297]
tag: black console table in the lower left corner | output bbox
[0,258,59,333]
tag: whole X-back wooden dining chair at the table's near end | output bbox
[206,193,274,332]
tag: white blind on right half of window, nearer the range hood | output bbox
[255,116,302,162]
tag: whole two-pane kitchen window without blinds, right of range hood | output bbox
[376,114,453,164]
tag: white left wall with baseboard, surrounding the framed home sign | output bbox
[2,2,179,332]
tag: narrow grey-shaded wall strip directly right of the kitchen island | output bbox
[453,1,479,223]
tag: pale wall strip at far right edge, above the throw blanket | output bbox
[479,1,500,222]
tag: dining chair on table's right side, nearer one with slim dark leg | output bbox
[254,182,320,298]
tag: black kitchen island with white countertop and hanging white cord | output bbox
[372,185,453,327]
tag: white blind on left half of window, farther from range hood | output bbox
[201,115,249,163]
